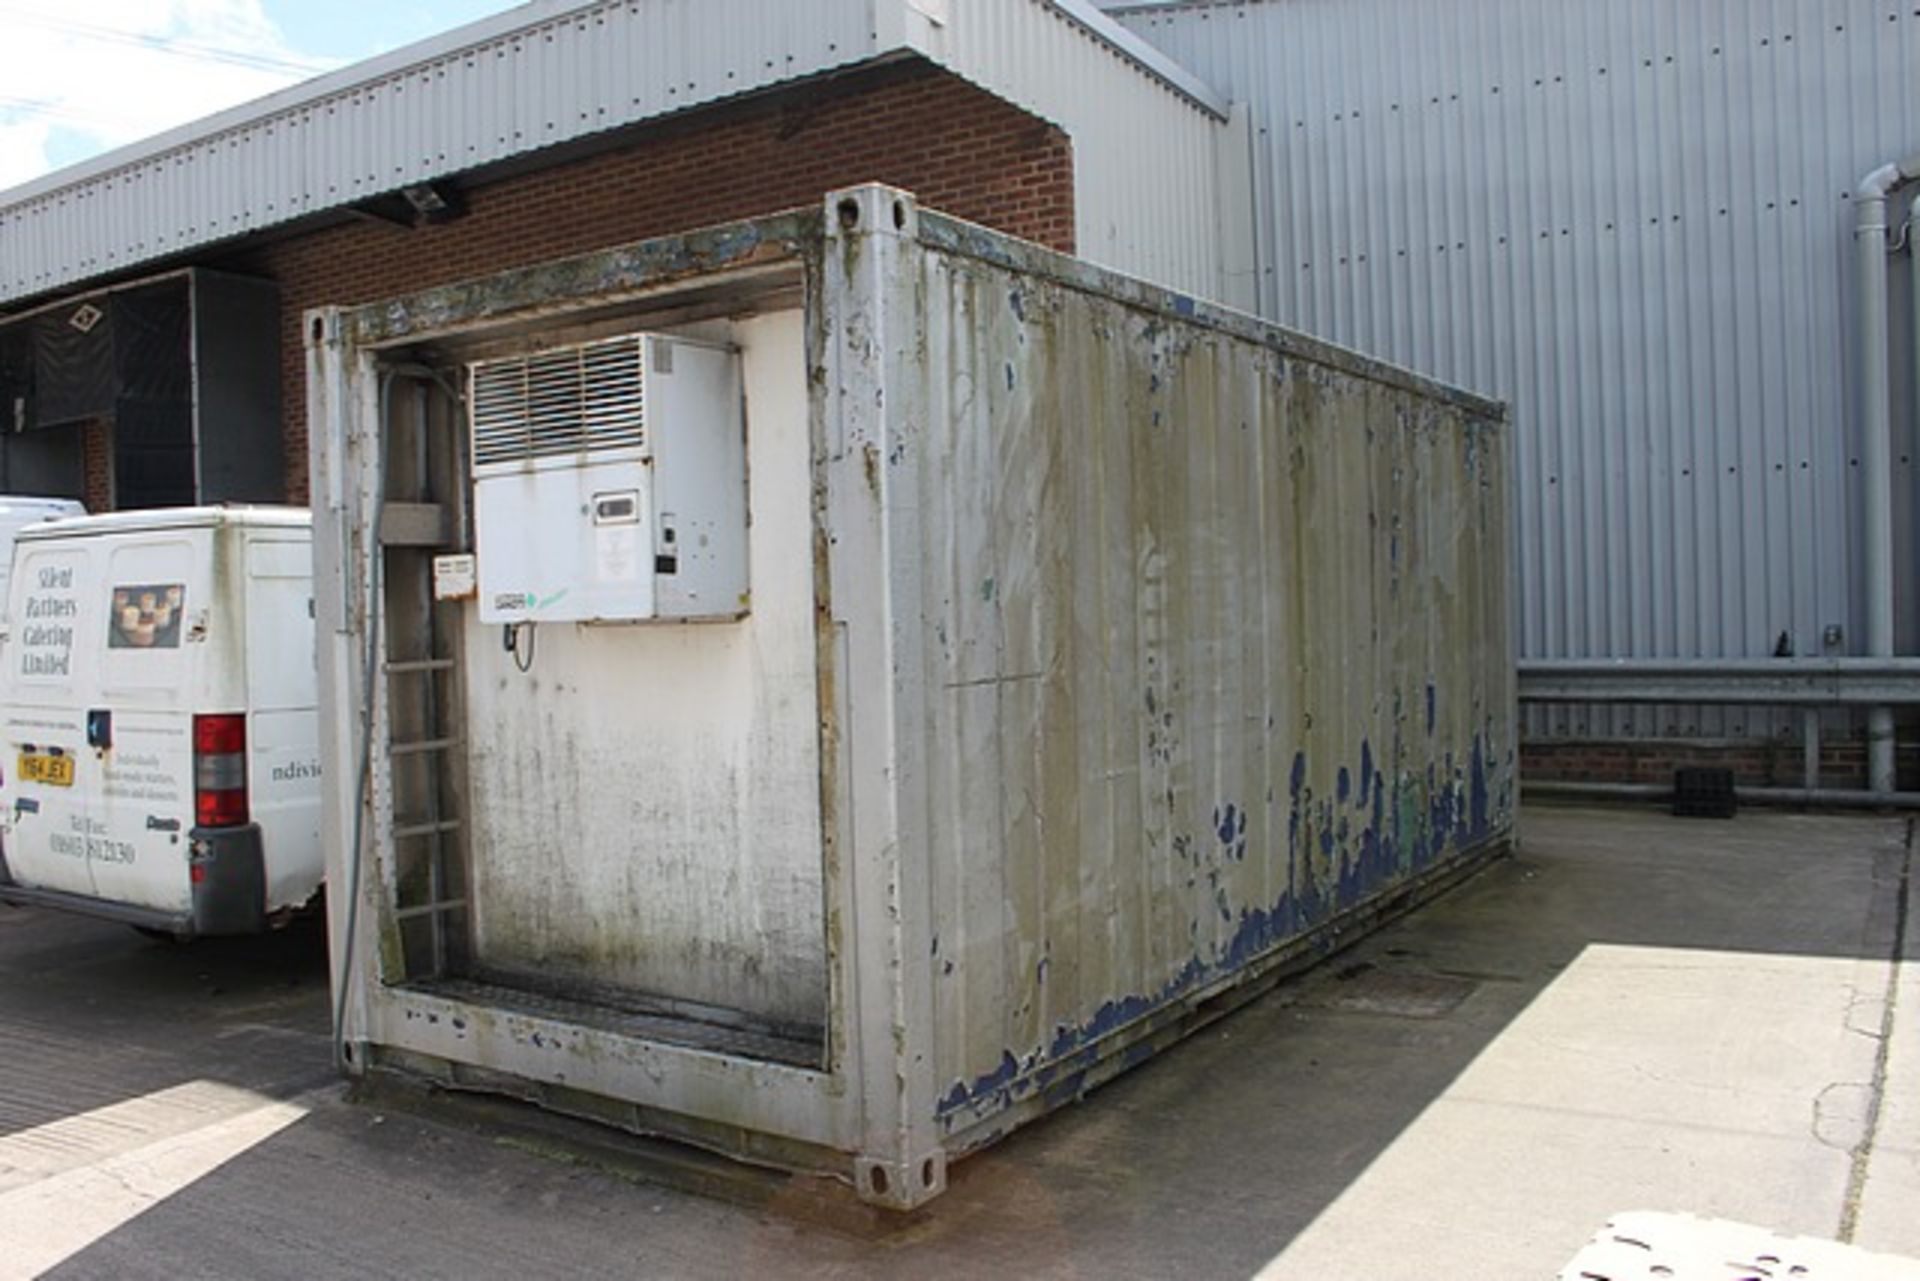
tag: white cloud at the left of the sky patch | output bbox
[0,0,332,188]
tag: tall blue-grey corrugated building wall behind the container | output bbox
[1119,0,1920,734]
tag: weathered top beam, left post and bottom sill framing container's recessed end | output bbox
[307,209,860,1170]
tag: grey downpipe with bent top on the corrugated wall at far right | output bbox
[1853,164,1920,793]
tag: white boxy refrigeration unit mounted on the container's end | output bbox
[468,334,749,626]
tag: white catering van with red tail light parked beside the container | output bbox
[0,507,323,939]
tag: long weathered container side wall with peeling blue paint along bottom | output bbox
[891,219,1515,1135]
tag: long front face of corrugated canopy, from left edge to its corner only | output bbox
[0,0,874,300]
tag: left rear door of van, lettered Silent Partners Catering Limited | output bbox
[0,542,104,895]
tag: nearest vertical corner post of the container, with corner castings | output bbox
[822,186,947,1208]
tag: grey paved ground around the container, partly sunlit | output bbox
[0,809,1920,1281]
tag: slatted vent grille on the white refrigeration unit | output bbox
[472,334,647,467]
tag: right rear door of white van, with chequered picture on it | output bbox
[81,528,204,914]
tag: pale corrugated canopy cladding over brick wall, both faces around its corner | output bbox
[0,0,1221,311]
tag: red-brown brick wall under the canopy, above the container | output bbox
[215,63,1073,503]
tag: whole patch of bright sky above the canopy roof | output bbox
[0,0,515,188]
